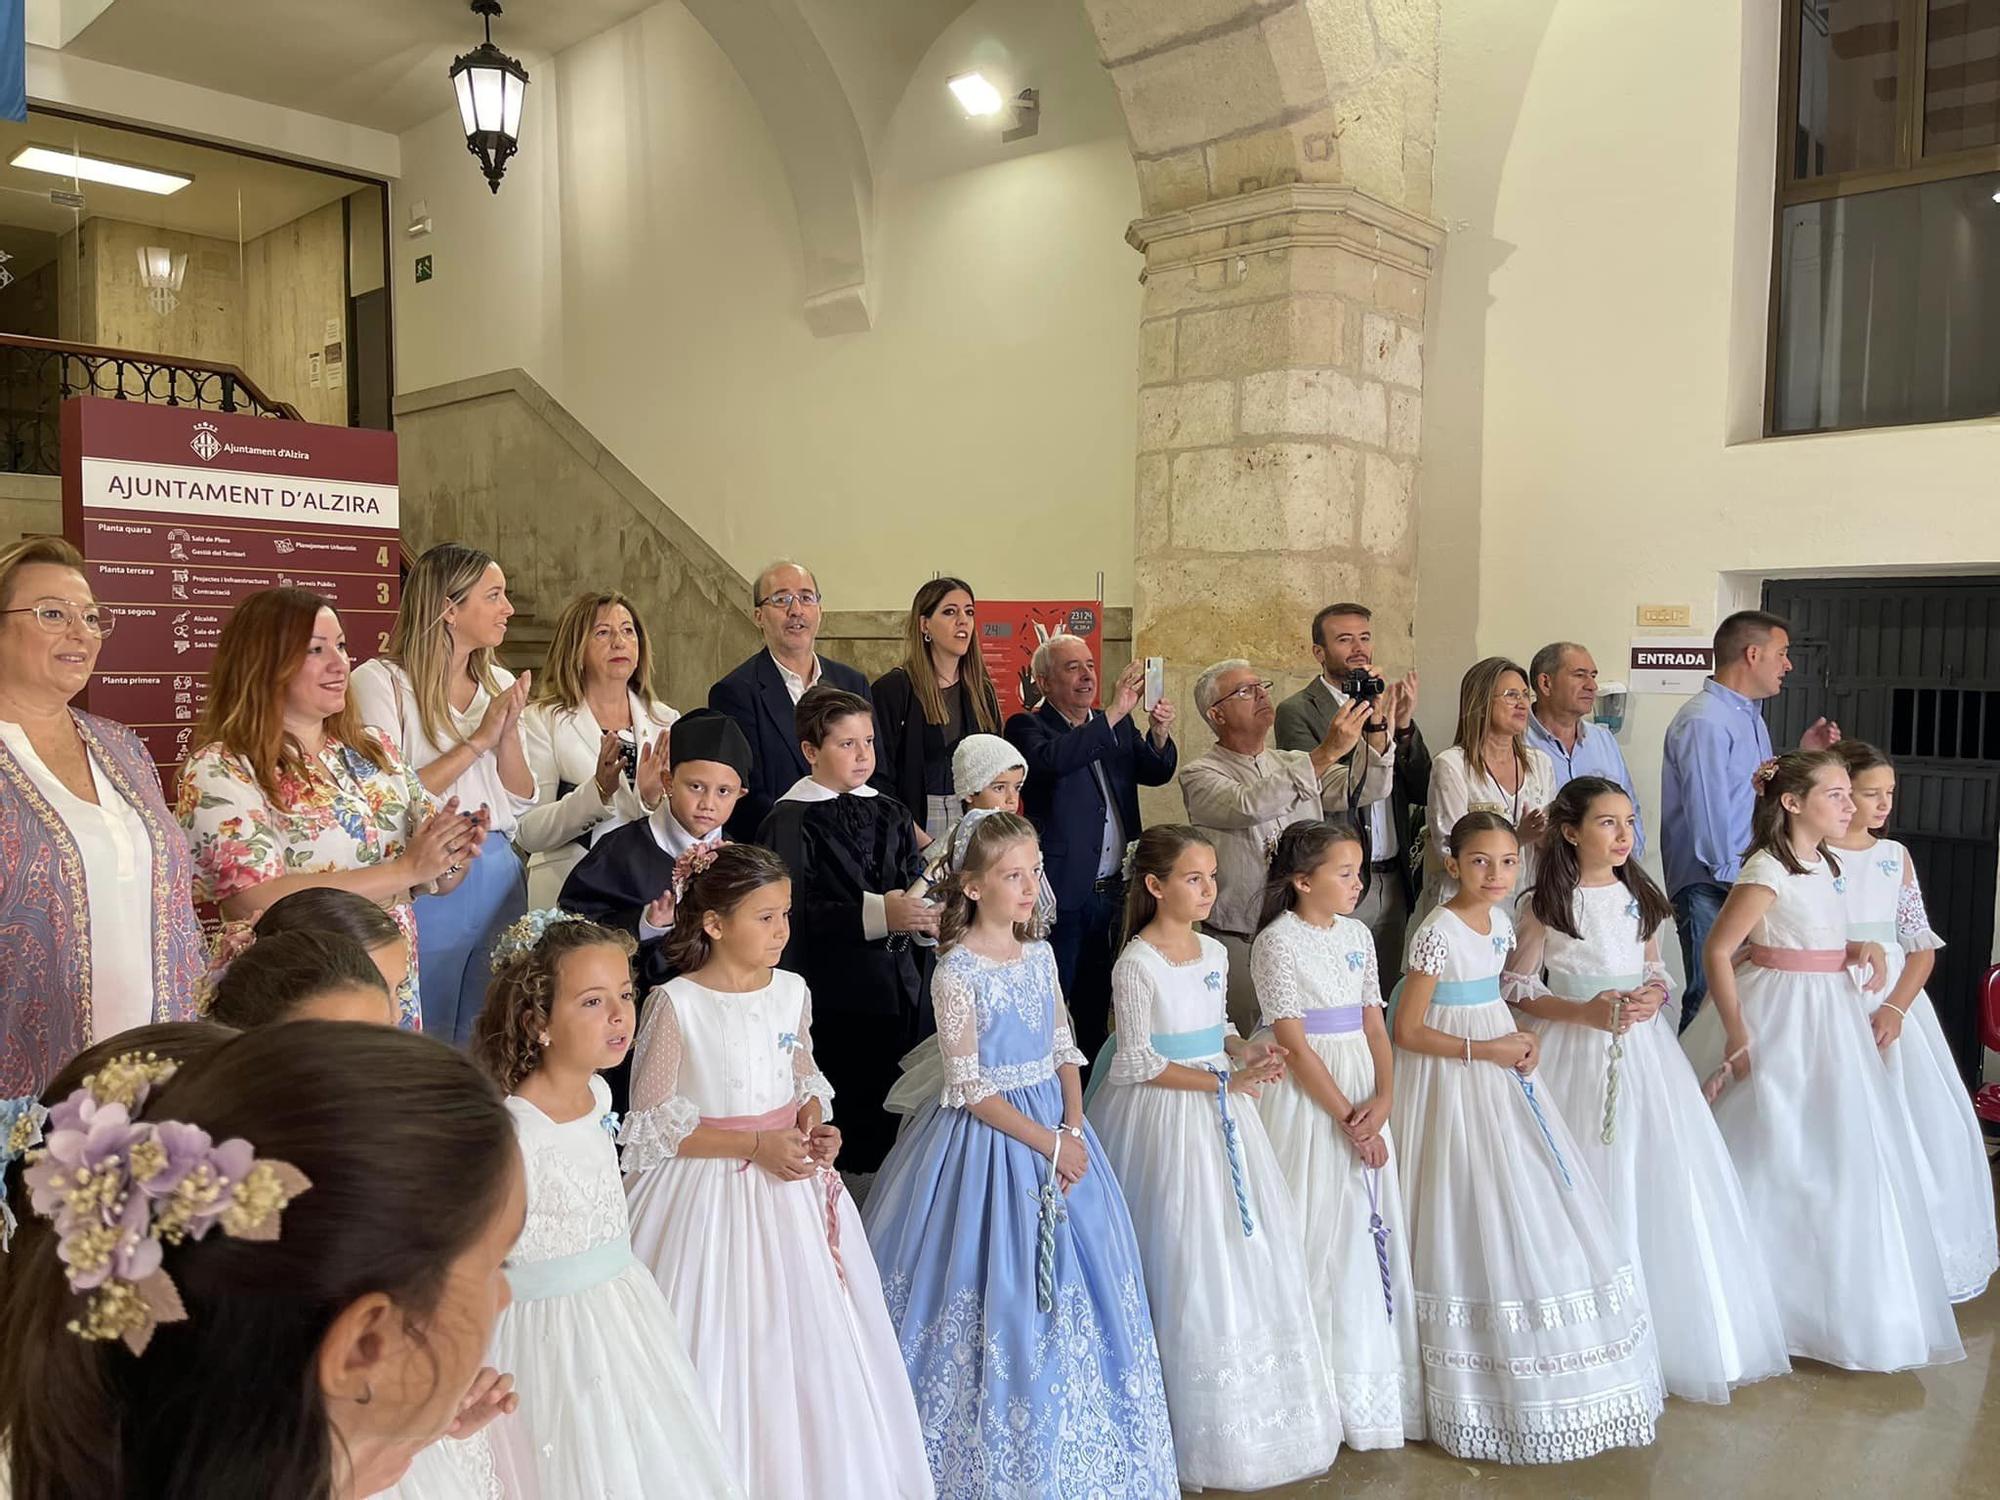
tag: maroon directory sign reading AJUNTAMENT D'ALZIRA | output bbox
[62,396,398,786]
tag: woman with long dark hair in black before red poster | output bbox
[870,578,1000,844]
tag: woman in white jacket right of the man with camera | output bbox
[1410,656,1556,932]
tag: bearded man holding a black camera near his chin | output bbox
[1276,604,1430,974]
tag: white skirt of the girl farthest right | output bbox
[1864,944,2000,1302]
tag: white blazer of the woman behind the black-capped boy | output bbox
[514,694,680,910]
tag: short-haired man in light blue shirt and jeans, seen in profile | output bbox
[1660,610,1840,1030]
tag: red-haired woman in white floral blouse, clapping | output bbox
[178,588,486,1030]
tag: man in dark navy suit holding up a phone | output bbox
[1006,636,1178,1060]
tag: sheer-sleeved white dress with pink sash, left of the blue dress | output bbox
[618,970,934,1500]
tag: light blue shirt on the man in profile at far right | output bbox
[1660,678,1770,896]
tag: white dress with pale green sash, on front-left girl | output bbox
[488,1078,744,1500]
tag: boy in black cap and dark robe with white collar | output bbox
[560,708,750,994]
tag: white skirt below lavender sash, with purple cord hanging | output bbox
[1258,1032,1424,1448]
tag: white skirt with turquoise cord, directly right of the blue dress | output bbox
[1090,1054,1340,1490]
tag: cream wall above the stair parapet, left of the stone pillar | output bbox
[394,0,1140,610]
